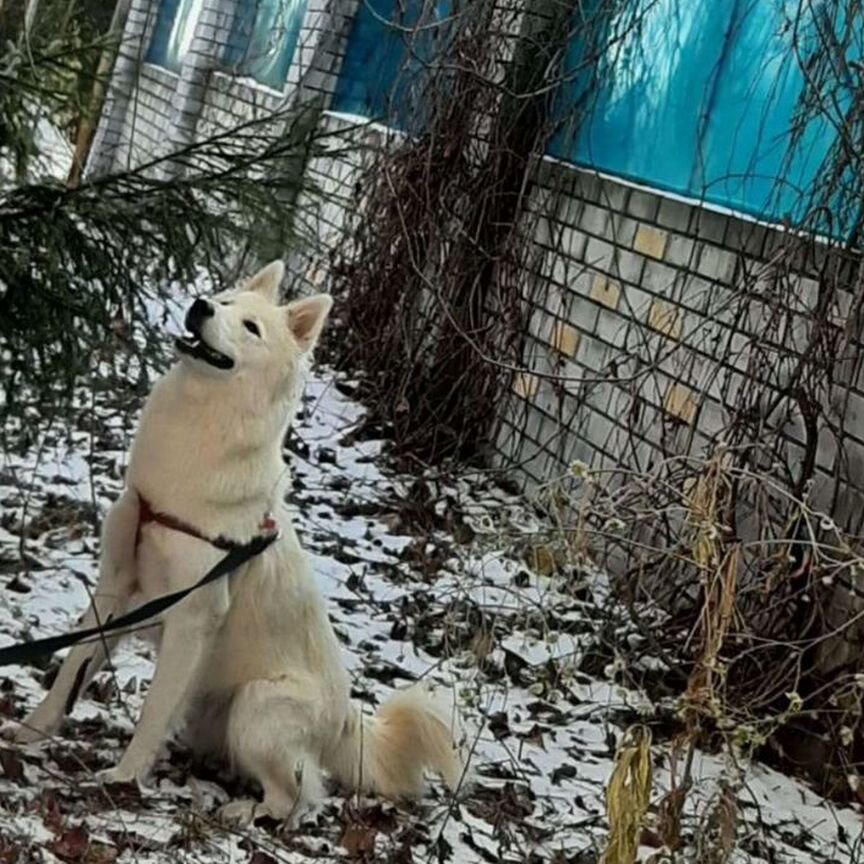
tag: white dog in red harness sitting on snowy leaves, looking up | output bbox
[10,262,462,821]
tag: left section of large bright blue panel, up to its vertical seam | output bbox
[550,0,734,202]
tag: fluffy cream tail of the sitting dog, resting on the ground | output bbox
[325,686,464,798]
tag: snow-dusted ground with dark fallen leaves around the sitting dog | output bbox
[0,350,862,864]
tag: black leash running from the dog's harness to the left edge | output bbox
[0,531,279,666]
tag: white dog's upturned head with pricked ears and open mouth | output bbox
[177,261,332,392]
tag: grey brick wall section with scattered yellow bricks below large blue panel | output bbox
[495,160,864,533]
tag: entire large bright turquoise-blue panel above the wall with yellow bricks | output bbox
[550,0,842,228]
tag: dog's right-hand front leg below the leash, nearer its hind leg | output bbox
[100,586,222,783]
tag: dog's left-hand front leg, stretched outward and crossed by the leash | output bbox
[10,491,138,744]
